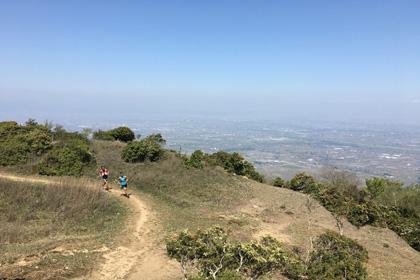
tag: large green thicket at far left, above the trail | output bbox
[0,119,94,176]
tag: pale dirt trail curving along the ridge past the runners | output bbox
[0,173,181,280]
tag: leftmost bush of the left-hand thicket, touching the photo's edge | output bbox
[0,120,52,166]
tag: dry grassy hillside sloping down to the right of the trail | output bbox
[92,141,420,279]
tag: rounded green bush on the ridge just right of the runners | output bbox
[121,134,166,163]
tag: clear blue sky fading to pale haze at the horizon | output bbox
[0,0,420,124]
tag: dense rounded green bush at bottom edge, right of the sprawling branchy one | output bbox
[307,231,368,280]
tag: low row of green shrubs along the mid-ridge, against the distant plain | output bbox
[185,150,264,182]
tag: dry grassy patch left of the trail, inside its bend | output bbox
[0,178,126,279]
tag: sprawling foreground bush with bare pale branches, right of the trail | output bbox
[166,227,304,279]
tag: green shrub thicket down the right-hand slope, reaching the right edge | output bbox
[276,173,420,251]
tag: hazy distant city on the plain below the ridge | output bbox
[66,119,420,184]
